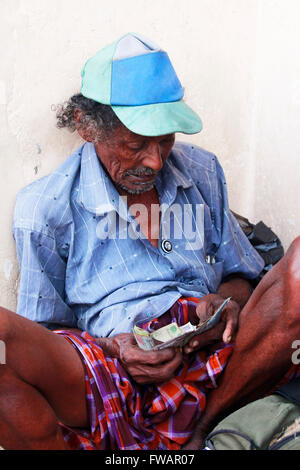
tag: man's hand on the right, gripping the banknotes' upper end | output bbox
[184,294,241,354]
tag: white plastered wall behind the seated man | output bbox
[0,0,300,309]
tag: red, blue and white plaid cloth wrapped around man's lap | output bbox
[57,298,233,450]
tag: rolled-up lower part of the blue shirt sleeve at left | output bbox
[13,228,77,328]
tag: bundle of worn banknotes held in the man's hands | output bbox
[133,297,231,351]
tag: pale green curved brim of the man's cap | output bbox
[112,100,202,136]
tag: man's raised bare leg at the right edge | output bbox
[185,237,300,449]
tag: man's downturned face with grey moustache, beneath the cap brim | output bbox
[95,127,175,194]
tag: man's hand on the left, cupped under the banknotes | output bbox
[95,333,182,384]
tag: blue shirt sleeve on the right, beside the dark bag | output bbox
[216,162,264,279]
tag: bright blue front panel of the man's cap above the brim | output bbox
[111,51,183,106]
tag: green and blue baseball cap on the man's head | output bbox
[80,33,202,136]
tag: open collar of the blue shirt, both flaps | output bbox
[77,142,192,217]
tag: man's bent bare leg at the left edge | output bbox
[0,309,88,449]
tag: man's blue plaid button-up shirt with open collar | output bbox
[13,143,264,336]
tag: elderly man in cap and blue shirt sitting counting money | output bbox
[0,34,300,449]
